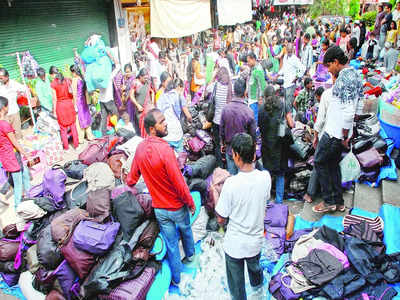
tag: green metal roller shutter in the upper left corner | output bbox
[0,0,109,78]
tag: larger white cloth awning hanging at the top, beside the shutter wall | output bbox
[150,0,211,38]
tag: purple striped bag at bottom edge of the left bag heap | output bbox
[98,268,156,300]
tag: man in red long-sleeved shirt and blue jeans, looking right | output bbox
[126,109,195,284]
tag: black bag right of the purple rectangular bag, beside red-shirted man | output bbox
[113,192,145,241]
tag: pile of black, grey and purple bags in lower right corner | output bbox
[264,204,400,300]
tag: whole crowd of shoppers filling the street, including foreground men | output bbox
[0,4,394,299]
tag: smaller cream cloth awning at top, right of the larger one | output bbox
[217,0,252,25]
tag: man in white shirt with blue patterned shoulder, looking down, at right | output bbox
[313,46,363,213]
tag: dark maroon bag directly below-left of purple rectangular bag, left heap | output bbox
[61,234,96,279]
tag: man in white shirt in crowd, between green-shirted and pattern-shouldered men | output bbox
[279,43,306,107]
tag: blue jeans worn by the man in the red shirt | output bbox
[154,206,194,283]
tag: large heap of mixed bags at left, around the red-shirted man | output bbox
[0,121,234,299]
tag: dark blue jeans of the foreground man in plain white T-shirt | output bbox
[225,253,263,300]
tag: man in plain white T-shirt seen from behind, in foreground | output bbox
[215,133,271,300]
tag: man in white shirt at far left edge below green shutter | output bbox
[0,68,26,139]
